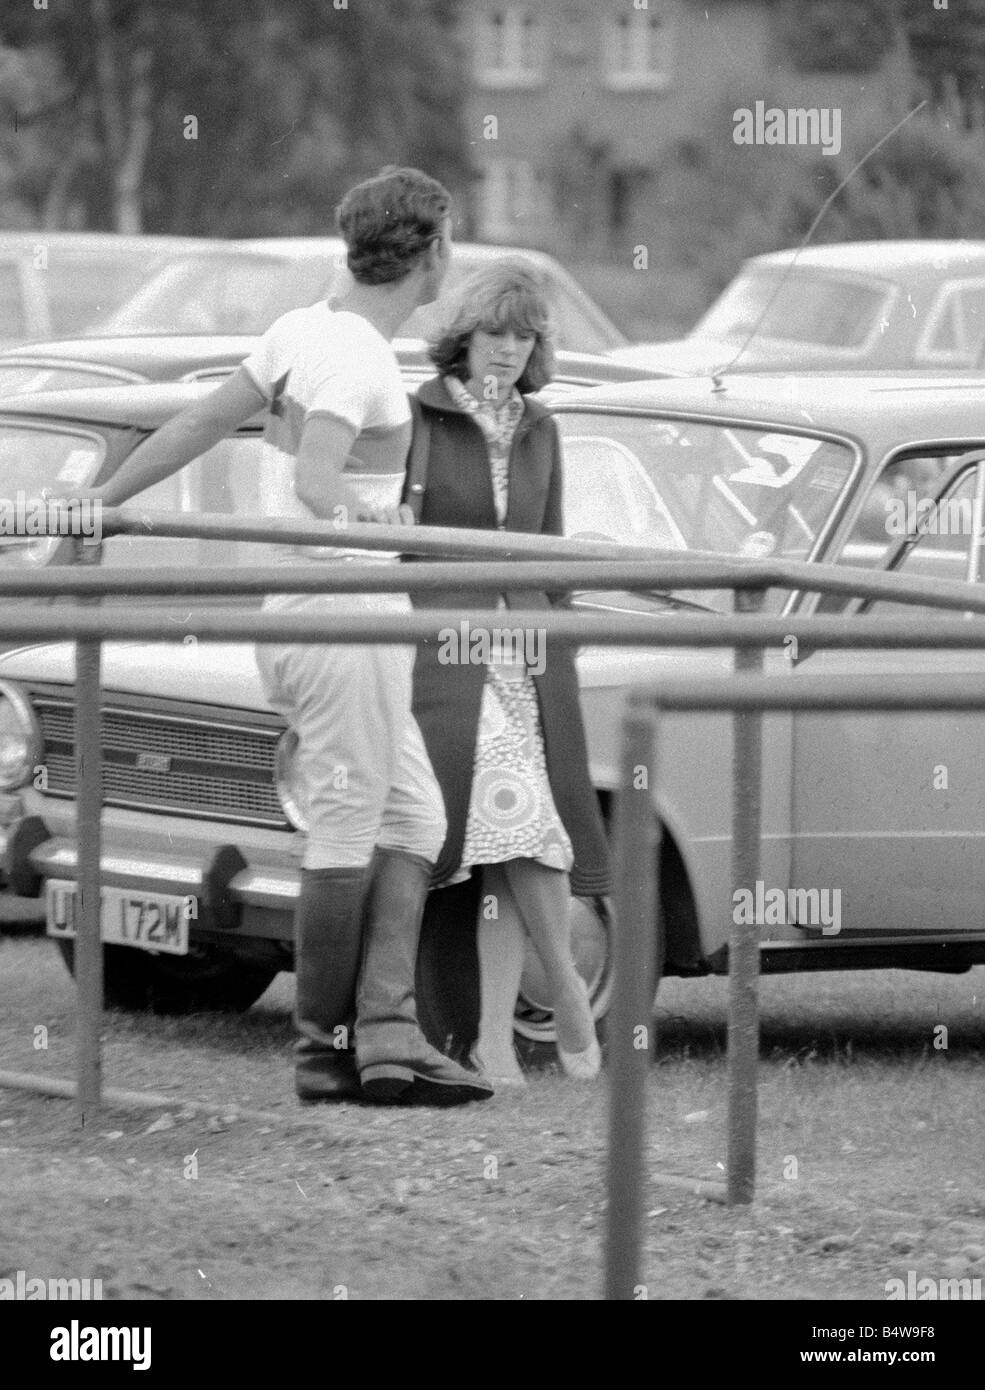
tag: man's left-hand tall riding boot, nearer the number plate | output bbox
[295,869,368,1101]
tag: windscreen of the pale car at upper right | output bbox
[692,265,892,349]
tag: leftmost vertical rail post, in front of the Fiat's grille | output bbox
[75,539,103,1126]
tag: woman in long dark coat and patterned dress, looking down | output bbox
[407,257,610,1084]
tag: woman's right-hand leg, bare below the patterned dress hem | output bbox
[502,859,595,1052]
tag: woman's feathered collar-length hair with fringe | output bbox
[428,256,554,396]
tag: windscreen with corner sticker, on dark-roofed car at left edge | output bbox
[0,421,103,566]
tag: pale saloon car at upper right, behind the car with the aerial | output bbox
[615,240,985,373]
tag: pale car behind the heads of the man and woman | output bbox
[94,236,627,353]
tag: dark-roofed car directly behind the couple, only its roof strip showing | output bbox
[0,334,665,399]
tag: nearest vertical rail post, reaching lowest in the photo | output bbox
[606,702,659,1300]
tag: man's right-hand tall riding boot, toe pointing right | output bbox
[356,848,493,1105]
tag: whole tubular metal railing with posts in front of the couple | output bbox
[0,507,985,1298]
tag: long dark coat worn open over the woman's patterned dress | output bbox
[404,377,611,897]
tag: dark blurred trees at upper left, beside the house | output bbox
[0,0,468,235]
